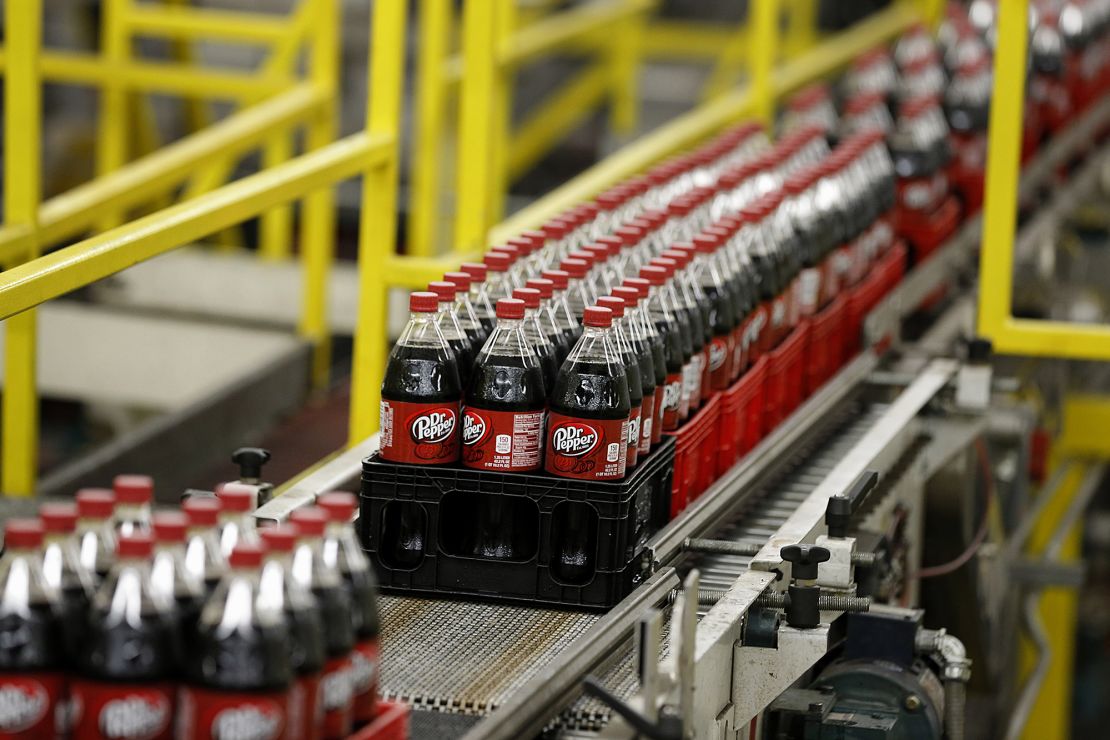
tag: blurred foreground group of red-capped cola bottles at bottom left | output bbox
[0,476,395,738]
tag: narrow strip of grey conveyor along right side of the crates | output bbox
[557,404,887,731]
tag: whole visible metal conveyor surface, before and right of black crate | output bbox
[381,404,886,731]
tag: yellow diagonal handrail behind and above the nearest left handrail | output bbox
[0,83,323,264]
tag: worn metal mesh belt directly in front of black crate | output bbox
[381,596,598,714]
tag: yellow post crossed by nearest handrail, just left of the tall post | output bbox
[299,0,337,388]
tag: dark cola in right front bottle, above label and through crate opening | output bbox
[551,361,632,584]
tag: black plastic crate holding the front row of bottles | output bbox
[359,439,675,609]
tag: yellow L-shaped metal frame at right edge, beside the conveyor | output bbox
[979,0,1110,361]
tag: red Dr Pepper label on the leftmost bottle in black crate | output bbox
[380,401,458,465]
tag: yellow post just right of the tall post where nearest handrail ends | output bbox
[405,0,452,257]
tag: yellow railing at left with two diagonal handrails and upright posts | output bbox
[0,0,405,495]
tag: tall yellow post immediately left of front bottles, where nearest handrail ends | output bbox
[349,2,406,444]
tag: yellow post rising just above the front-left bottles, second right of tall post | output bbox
[454,0,506,252]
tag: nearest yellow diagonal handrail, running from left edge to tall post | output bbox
[0,133,395,318]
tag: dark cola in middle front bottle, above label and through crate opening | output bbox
[465,355,546,560]
